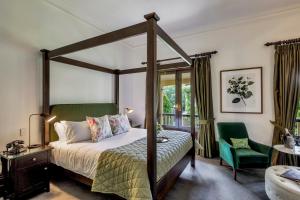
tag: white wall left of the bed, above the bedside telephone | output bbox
[0,31,42,150]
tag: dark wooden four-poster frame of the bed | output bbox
[41,13,195,199]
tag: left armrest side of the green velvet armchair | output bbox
[219,138,236,168]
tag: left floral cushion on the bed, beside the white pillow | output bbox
[86,115,113,142]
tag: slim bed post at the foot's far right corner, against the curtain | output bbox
[191,64,196,167]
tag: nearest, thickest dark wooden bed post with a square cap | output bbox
[144,13,159,200]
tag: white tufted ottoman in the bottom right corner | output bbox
[265,165,300,200]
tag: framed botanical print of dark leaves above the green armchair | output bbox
[220,67,263,114]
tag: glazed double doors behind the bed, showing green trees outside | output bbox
[159,70,198,130]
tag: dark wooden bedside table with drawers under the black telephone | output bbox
[0,147,52,199]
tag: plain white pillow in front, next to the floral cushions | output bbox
[62,121,92,144]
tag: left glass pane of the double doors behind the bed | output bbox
[160,74,176,126]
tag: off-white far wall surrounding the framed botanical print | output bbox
[121,10,300,144]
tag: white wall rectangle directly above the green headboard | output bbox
[50,62,114,105]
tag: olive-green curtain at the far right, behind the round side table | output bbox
[272,44,300,165]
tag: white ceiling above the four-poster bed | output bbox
[0,0,300,69]
